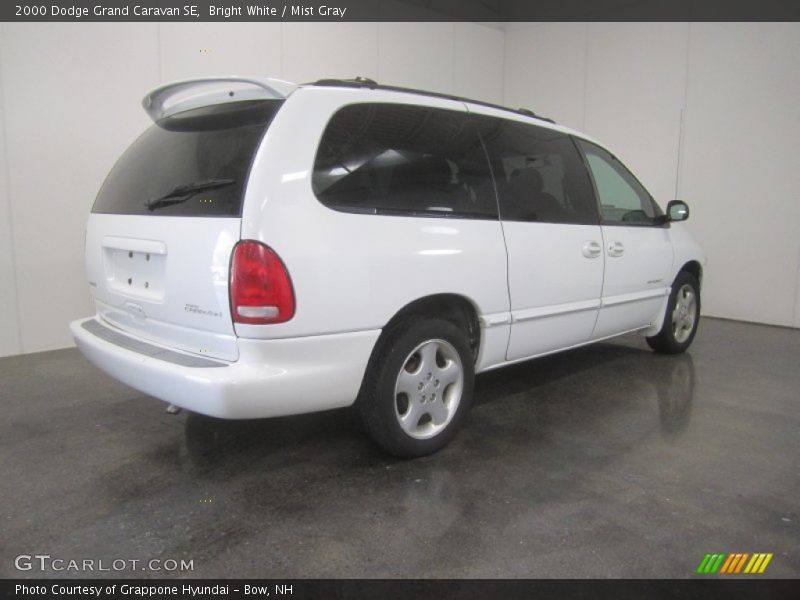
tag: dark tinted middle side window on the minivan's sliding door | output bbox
[481,119,598,224]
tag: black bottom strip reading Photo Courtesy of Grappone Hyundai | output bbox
[0,576,800,600]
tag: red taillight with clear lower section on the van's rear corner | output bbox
[230,240,295,325]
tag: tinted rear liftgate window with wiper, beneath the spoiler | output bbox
[92,100,283,217]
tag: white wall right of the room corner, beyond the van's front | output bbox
[504,23,800,327]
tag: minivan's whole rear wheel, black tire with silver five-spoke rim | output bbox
[358,318,475,458]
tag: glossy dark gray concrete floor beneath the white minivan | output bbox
[0,319,800,577]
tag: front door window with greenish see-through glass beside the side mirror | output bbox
[578,140,661,225]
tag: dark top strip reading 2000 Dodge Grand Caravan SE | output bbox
[0,0,800,23]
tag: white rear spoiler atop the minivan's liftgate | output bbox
[142,75,297,121]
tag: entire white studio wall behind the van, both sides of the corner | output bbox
[0,23,800,356]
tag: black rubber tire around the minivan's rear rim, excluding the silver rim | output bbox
[361,319,475,458]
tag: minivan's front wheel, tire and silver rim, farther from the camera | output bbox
[647,271,700,354]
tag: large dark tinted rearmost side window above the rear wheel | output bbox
[312,103,497,219]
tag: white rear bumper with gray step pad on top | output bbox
[70,317,380,419]
